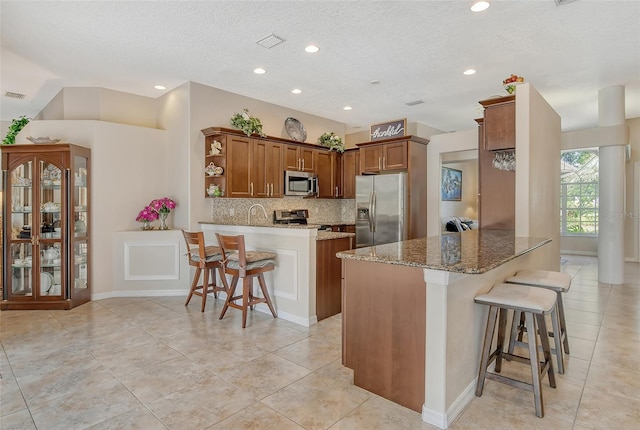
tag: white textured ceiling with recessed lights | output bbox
[0,0,640,132]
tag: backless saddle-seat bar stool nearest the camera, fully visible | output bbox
[475,284,556,418]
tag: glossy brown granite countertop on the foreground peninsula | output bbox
[336,230,551,274]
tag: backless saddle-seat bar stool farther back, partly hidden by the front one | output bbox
[505,269,571,374]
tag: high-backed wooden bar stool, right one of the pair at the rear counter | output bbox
[216,233,278,328]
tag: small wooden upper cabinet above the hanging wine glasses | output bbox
[480,95,516,151]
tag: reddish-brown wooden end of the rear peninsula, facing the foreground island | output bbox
[316,237,353,321]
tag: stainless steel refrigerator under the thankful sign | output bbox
[356,173,409,248]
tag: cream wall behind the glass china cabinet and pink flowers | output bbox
[18,121,172,294]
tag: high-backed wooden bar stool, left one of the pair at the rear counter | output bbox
[182,230,227,312]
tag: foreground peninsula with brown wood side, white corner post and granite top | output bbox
[338,230,551,428]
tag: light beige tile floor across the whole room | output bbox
[0,256,640,430]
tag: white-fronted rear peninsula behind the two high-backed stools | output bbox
[200,221,355,327]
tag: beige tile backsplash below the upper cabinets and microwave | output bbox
[211,197,356,224]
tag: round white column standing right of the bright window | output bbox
[598,86,625,284]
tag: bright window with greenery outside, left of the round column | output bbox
[560,148,598,236]
